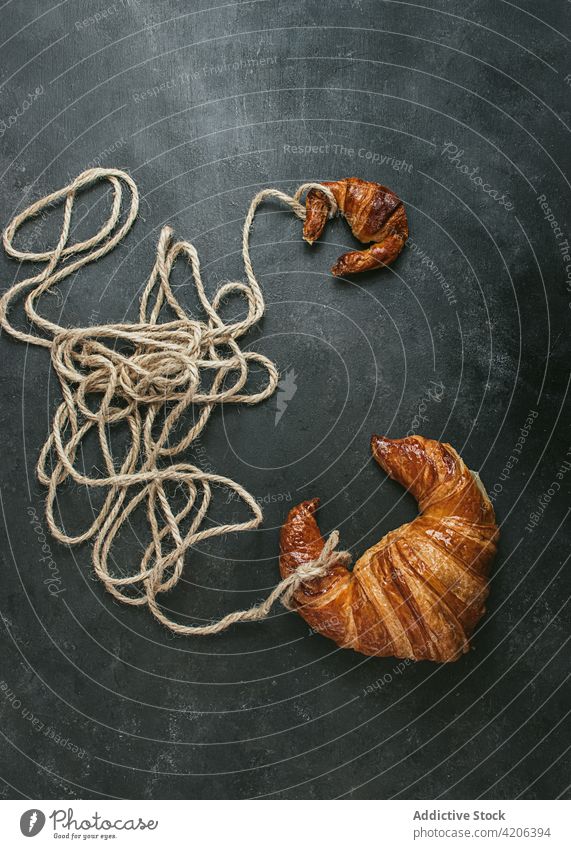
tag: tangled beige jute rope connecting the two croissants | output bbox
[0,168,348,635]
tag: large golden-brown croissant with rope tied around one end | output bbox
[280,436,498,662]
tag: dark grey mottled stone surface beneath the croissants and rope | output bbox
[0,0,571,799]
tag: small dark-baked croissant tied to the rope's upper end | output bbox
[303,177,408,277]
